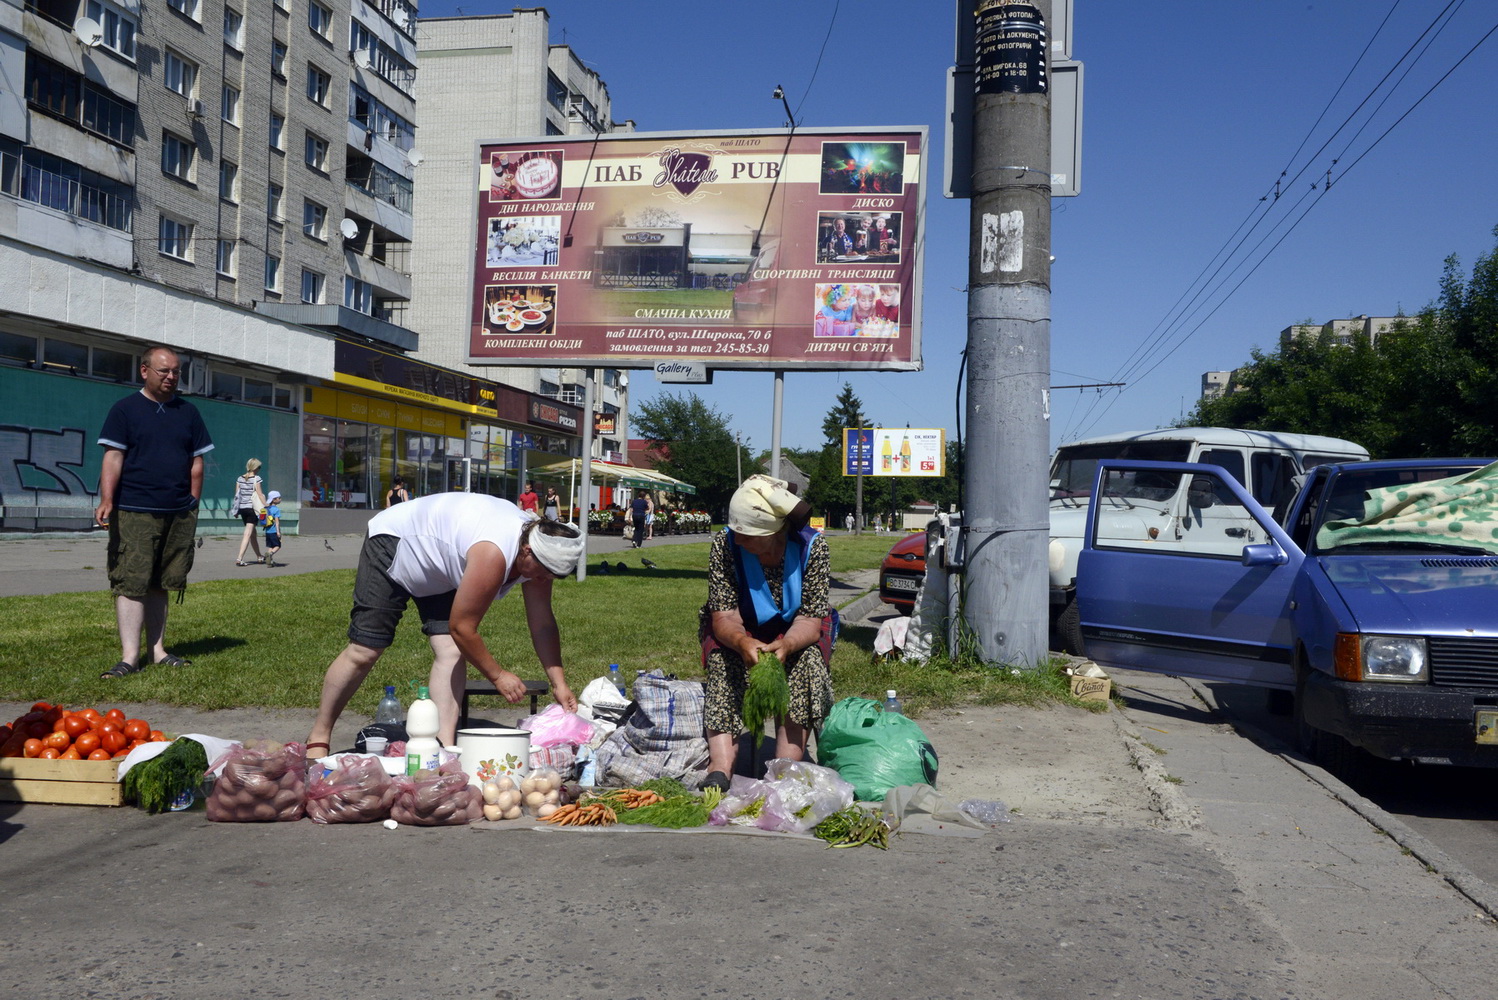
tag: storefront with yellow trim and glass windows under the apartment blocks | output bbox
[300,341,581,509]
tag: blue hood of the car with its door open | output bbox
[1315,554,1498,635]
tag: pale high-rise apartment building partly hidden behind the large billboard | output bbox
[410,7,634,461]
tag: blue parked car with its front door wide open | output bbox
[1077,458,1498,771]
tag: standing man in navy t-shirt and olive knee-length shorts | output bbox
[94,346,213,680]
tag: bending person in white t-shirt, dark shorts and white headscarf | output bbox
[307,493,583,756]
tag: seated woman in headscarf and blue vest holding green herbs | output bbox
[698,476,836,789]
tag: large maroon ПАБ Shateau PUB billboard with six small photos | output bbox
[467,127,926,370]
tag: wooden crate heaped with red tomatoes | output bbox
[0,702,166,805]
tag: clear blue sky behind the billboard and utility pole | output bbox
[421,0,1498,449]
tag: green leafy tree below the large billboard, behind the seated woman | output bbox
[631,392,750,516]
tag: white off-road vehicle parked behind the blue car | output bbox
[1049,427,1368,653]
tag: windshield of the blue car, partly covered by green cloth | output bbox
[1312,463,1488,555]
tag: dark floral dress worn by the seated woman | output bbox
[700,531,833,737]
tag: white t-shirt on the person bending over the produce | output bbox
[369,493,530,599]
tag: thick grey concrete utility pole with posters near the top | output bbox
[962,0,1050,666]
